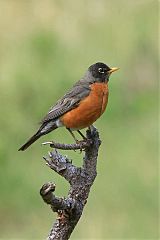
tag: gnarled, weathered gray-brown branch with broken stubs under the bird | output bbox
[40,127,101,240]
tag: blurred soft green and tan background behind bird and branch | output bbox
[0,0,158,239]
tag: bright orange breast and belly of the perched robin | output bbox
[60,83,109,130]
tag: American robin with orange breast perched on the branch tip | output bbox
[19,62,118,151]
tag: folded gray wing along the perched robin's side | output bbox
[41,81,91,124]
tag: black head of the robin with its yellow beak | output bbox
[88,62,118,82]
